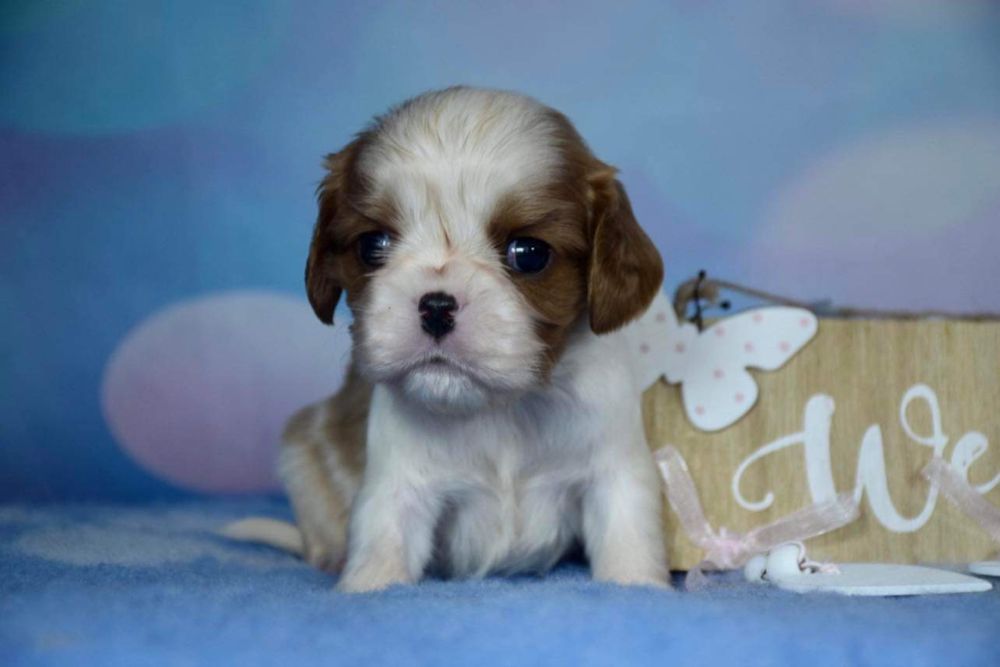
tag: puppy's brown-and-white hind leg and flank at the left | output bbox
[280,369,371,571]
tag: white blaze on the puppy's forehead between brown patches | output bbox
[360,88,559,243]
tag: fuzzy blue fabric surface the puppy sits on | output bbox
[0,500,1000,667]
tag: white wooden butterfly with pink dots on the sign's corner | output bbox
[625,280,819,431]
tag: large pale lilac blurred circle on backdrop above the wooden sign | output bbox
[745,118,1000,313]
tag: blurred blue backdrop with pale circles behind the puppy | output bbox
[0,0,1000,500]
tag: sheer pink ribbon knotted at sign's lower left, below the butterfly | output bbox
[656,446,859,590]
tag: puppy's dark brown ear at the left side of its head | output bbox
[306,144,354,324]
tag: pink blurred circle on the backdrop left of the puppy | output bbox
[101,291,350,493]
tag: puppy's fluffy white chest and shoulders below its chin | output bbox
[352,330,662,576]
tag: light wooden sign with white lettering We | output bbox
[637,318,1000,569]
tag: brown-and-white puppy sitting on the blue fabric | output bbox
[230,87,668,592]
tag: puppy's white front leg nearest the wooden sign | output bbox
[583,444,669,586]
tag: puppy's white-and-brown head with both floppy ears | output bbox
[306,88,663,412]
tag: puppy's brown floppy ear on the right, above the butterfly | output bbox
[587,167,663,334]
